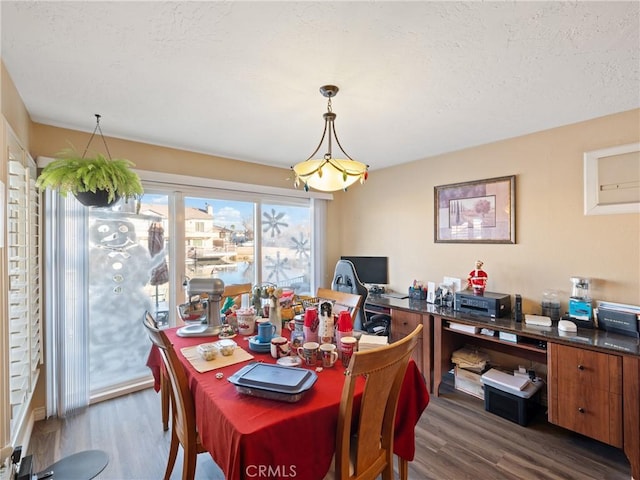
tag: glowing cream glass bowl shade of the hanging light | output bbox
[293,158,367,192]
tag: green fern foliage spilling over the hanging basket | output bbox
[36,149,144,202]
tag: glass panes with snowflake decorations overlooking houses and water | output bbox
[184,197,311,293]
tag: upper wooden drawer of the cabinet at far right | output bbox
[555,345,622,394]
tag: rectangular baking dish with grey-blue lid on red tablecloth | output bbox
[228,363,318,402]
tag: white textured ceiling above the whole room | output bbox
[0,0,640,170]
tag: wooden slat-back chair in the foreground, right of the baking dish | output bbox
[335,325,422,480]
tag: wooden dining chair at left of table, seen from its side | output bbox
[143,312,206,480]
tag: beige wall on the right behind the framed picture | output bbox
[327,110,640,312]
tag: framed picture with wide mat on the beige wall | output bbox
[434,175,516,244]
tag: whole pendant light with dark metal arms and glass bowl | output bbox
[291,85,369,192]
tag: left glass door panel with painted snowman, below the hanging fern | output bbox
[86,189,171,397]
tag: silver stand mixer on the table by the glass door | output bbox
[176,278,224,337]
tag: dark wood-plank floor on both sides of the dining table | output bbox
[29,389,631,480]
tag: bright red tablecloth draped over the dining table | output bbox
[147,328,429,480]
